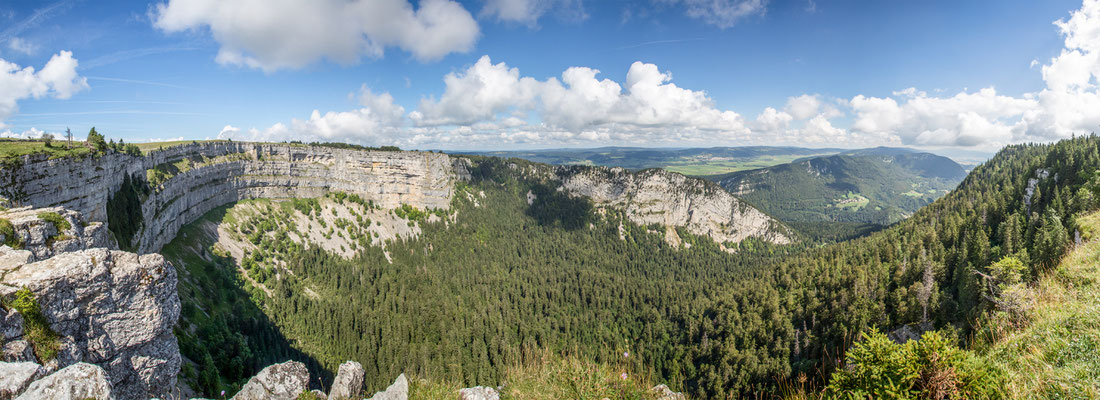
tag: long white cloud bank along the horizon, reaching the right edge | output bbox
[216,0,1100,151]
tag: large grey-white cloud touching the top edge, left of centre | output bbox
[152,0,480,71]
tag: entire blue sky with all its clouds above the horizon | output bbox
[0,0,1100,151]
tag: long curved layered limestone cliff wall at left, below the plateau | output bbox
[0,142,457,253]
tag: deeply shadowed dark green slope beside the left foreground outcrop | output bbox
[162,203,332,398]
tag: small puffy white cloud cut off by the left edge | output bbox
[0,51,88,126]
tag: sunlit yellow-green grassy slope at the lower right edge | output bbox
[982,213,1100,399]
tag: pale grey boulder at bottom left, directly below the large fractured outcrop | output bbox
[15,363,114,400]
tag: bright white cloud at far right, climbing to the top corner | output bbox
[850,0,1100,148]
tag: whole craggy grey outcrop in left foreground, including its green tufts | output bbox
[0,209,180,399]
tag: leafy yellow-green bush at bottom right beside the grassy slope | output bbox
[825,332,1002,399]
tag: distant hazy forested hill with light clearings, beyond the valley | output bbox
[707,148,966,226]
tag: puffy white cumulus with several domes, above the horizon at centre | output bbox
[410,56,745,137]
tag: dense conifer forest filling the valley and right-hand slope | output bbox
[176,136,1100,398]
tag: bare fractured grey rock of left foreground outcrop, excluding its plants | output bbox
[0,209,180,399]
